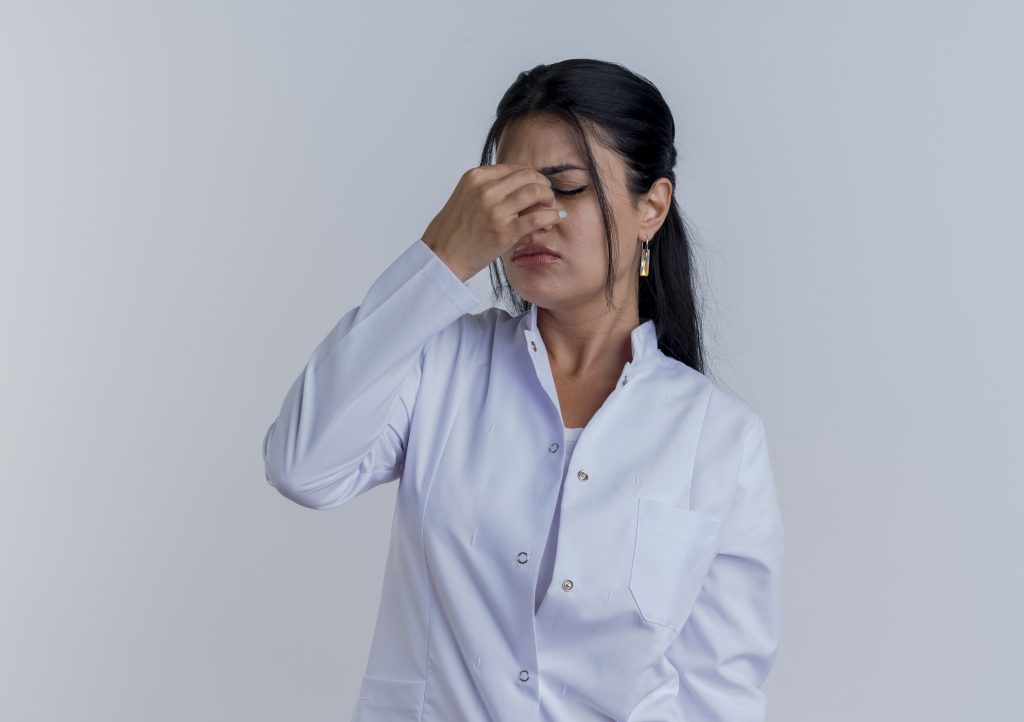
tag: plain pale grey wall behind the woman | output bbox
[0,0,1024,722]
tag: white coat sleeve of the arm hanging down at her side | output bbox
[668,417,783,722]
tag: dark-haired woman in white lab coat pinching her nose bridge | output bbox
[263,59,782,722]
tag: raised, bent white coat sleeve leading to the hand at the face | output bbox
[263,239,478,509]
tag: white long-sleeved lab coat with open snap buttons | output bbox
[263,239,782,722]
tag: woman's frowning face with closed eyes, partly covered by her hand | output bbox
[496,116,671,312]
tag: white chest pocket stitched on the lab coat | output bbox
[630,497,719,632]
